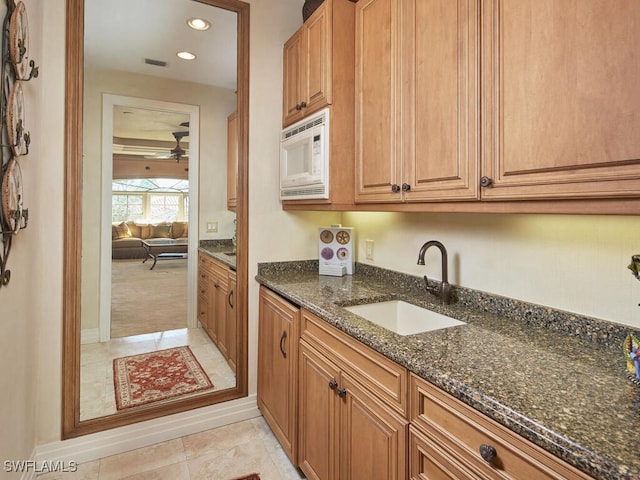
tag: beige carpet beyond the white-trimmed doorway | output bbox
[111,259,187,338]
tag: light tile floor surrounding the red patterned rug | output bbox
[80,328,236,420]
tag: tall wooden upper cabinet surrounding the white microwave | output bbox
[282,0,355,210]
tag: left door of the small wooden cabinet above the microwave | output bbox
[282,27,307,126]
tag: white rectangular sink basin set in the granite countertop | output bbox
[345,300,465,335]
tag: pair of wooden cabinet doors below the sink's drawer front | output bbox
[298,341,409,480]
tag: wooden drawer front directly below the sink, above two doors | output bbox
[301,309,407,416]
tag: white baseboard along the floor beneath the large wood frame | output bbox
[34,394,261,466]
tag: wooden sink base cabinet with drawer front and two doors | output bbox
[298,310,409,480]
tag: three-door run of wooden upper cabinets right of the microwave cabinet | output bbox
[355,0,640,203]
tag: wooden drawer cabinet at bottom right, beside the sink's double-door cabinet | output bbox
[409,374,591,480]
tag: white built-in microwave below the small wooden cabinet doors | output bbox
[280,108,329,200]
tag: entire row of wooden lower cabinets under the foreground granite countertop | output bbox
[258,287,591,480]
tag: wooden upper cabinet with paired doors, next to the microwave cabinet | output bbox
[355,0,479,203]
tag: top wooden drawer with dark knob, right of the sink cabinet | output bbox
[410,374,591,480]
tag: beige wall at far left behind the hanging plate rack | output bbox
[0,0,64,468]
